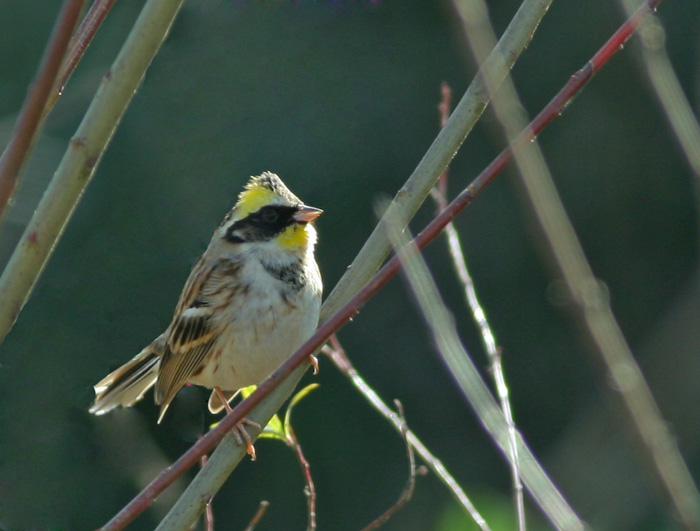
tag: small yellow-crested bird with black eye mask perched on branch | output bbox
[90,172,323,458]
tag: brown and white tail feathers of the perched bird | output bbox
[90,338,162,415]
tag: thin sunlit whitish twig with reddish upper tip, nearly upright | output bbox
[431,83,526,531]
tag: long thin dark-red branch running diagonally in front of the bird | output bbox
[95,0,662,531]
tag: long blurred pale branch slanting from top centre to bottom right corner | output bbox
[458,0,700,529]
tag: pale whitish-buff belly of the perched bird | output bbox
[190,290,320,391]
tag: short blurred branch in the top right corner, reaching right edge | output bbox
[622,0,700,237]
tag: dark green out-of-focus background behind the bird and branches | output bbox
[0,0,700,531]
